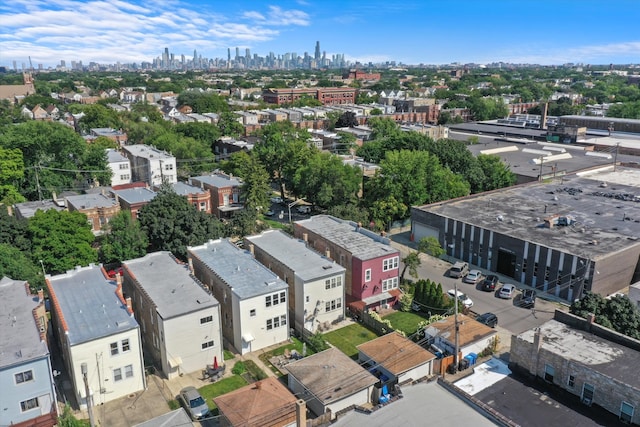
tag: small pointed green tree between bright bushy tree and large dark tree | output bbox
[100,211,149,264]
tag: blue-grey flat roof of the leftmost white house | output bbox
[46,265,138,345]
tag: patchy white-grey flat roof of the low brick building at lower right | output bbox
[518,319,640,389]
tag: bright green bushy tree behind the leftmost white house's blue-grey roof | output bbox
[29,209,98,274]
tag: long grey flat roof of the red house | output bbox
[295,215,399,260]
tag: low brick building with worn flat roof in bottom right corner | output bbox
[509,310,640,425]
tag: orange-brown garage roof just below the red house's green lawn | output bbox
[357,332,436,380]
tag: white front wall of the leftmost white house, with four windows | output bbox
[69,328,145,408]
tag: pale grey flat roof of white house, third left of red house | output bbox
[122,251,218,319]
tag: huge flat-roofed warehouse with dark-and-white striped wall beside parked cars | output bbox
[411,166,640,302]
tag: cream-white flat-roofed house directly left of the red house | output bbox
[246,230,345,333]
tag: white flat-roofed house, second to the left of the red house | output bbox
[187,239,289,354]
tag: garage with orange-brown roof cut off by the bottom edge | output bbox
[213,377,298,427]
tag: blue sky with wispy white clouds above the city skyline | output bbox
[0,0,640,67]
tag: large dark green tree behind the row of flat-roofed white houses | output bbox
[138,186,223,260]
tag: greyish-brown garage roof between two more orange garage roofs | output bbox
[284,347,378,405]
